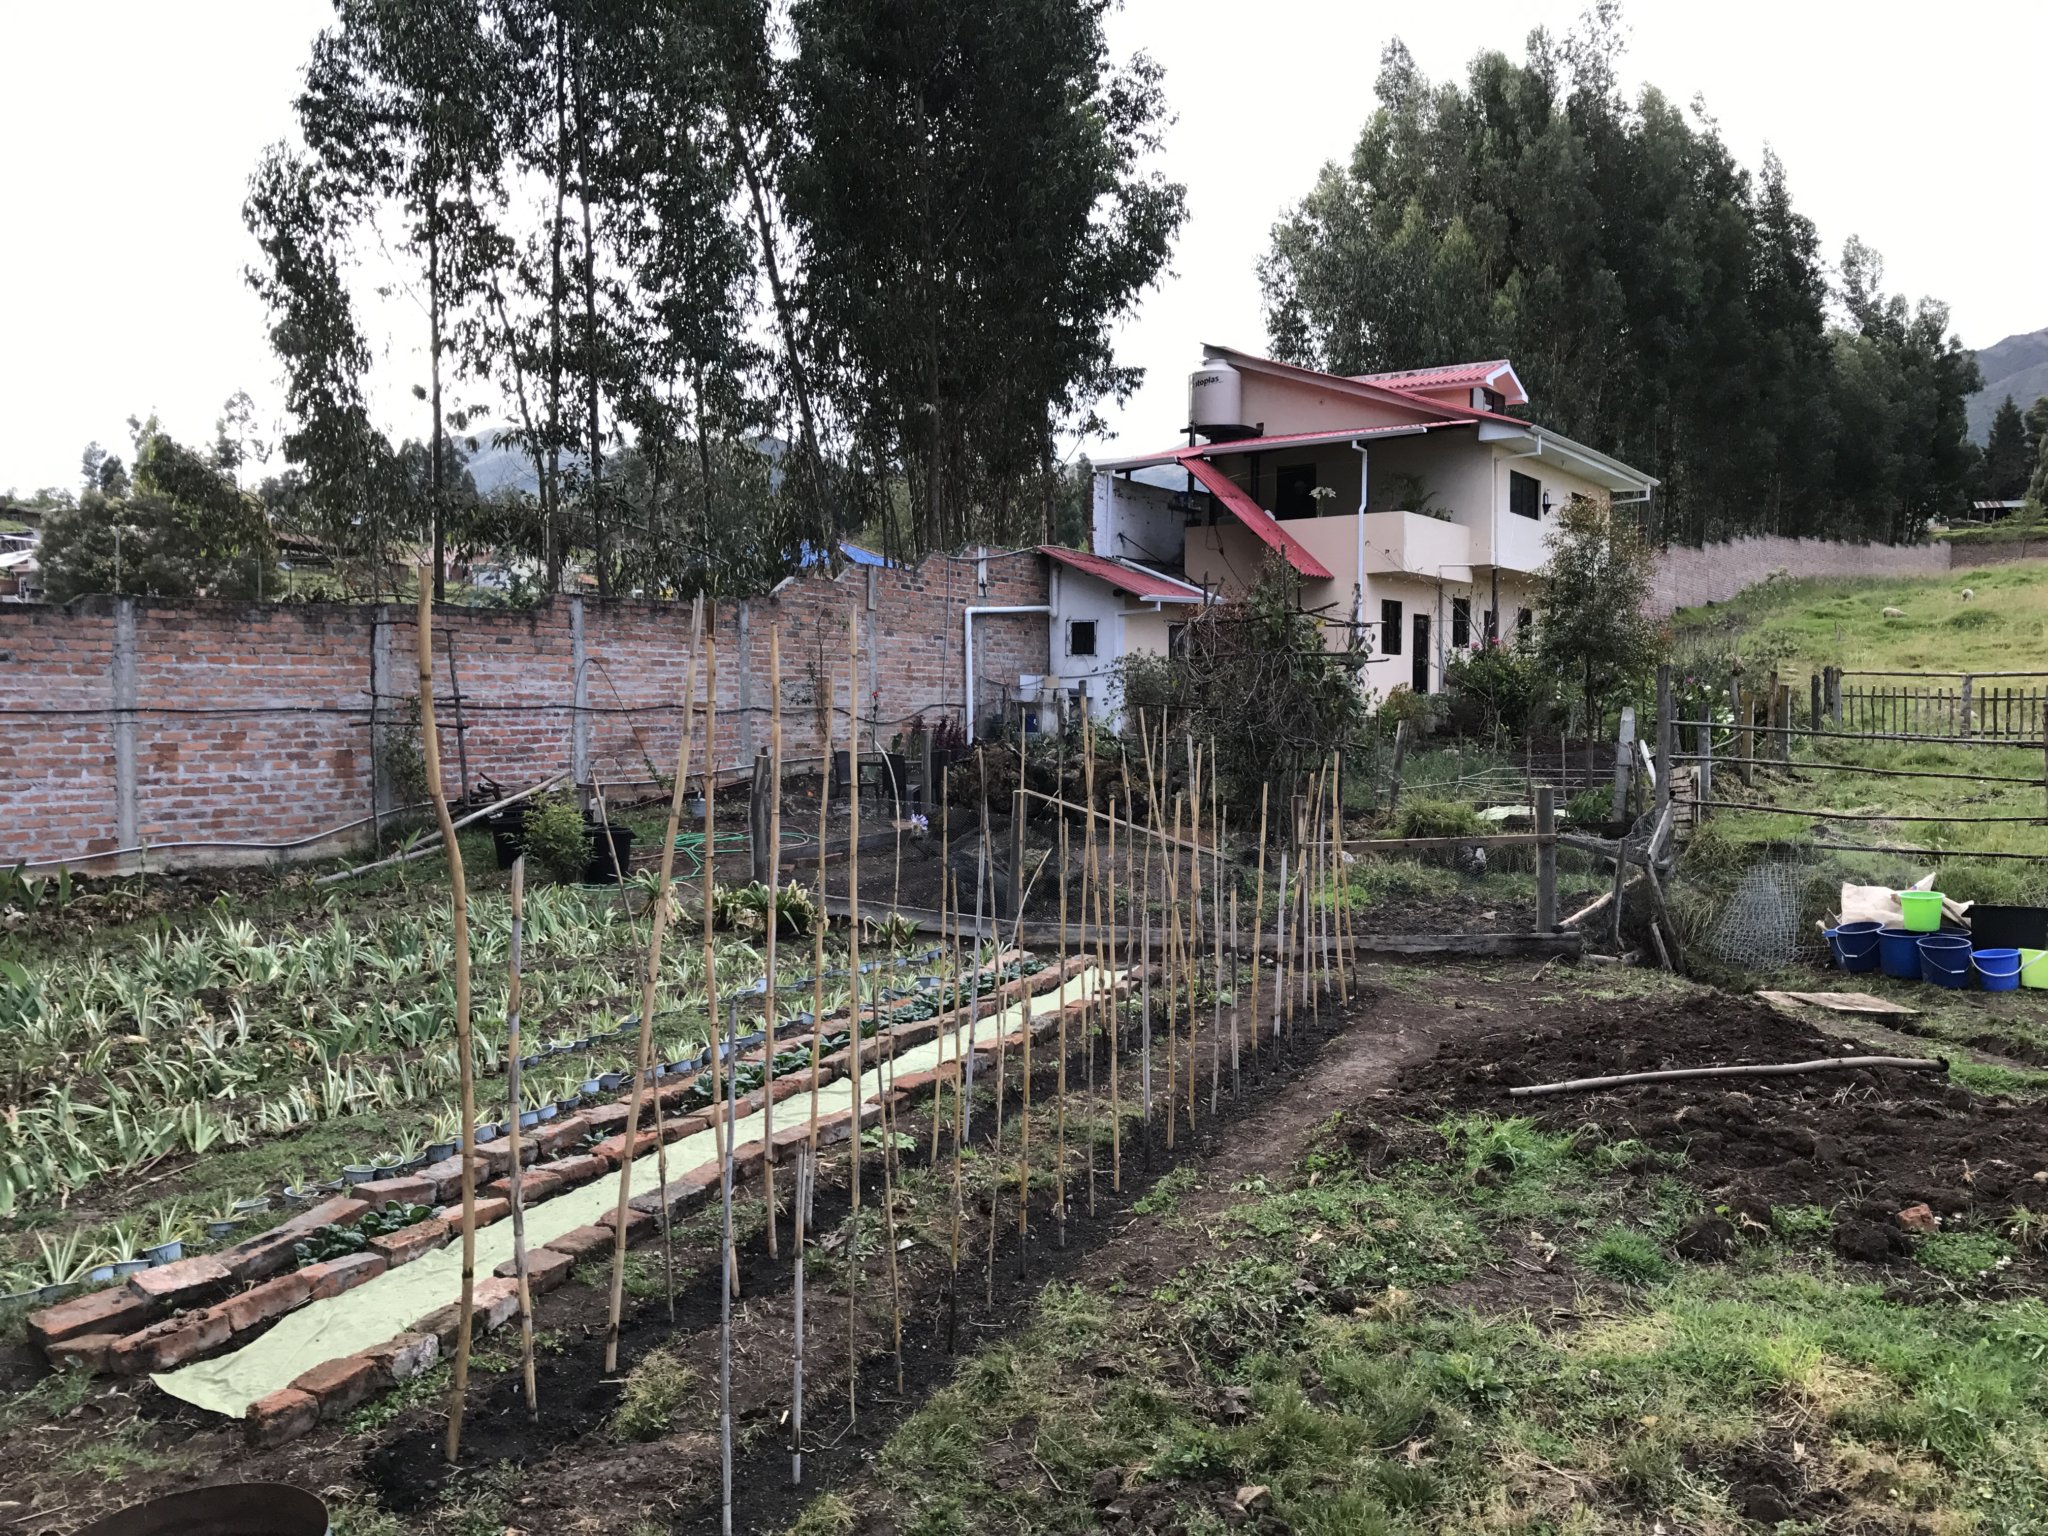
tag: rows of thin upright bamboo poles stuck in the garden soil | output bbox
[418,571,1356,1532]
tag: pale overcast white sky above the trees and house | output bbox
[0,0,2048,492]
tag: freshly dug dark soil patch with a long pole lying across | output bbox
[1401,993,2048,1262]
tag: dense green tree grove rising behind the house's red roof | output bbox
[1260,4,1976,543]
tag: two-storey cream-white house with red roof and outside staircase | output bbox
[1044,346,1657,711]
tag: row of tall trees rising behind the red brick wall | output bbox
[246,0,1182,594]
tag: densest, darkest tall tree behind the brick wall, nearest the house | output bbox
[782,0,1184,553]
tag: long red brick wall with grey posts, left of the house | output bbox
[0,551,1049,866]
